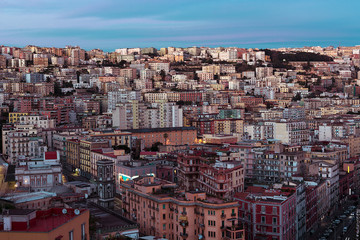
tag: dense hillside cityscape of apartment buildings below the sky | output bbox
[0,45,360,240]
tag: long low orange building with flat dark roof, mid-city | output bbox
[125,127,196,148]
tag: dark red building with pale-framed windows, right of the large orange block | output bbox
[235,187,296,240]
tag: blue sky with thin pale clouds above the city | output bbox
[0,0,360,51]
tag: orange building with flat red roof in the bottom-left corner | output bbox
[0,208,90,240]
